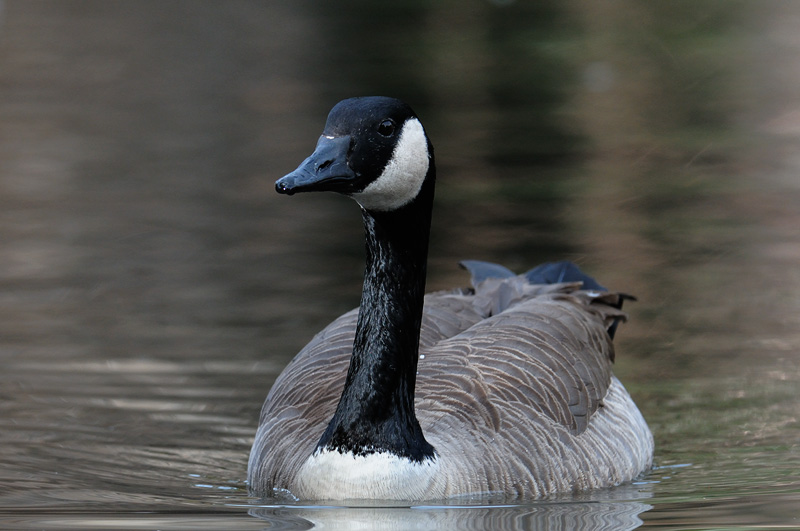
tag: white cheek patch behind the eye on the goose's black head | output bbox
[352,118,430,211]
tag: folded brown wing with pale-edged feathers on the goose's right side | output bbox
[416,293,615,435]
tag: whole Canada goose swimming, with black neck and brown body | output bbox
[248,97,653,500]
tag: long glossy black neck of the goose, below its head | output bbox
[318,172,434,461]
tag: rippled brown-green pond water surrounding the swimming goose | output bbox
[0,0,800,529]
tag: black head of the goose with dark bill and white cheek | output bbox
[275,97,434,212]
